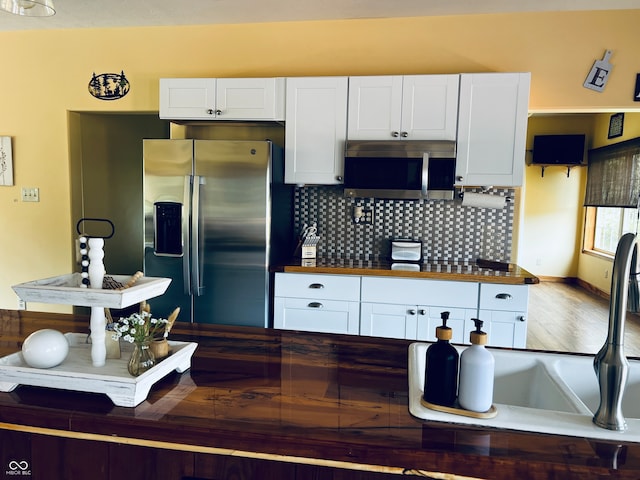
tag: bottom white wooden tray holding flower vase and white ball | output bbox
[0,333,198,407]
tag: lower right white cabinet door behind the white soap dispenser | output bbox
[479,310,527,348]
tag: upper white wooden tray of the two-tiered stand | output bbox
[11,273,171,309]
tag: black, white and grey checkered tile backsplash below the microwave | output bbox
[294,186,515,262]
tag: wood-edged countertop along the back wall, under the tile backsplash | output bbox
[274,258,539,285]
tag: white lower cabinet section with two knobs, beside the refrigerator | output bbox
[273,273,360,335]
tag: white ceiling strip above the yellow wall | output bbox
[0,0,640,31]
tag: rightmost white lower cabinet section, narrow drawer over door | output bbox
[478,283,529,348]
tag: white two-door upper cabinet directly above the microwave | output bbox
[347,75,459,140]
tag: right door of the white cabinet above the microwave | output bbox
[400,75,460,141]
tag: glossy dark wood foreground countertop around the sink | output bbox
[0,310,640,480]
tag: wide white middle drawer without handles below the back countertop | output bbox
[362,277,478,308]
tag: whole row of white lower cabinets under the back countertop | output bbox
[274,273,529,348]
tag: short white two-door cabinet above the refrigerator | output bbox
[160,78,285,121]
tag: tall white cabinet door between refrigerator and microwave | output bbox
[284,77,348,185]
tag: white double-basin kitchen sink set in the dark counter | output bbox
[409,342,640,442]
